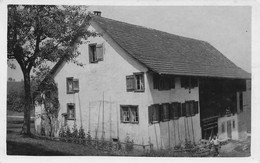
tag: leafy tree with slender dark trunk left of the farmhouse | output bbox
[7,5,95,135]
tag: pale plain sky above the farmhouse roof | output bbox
[8,6,251,80]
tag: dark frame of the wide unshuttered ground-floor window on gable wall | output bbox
[120,105,140,124]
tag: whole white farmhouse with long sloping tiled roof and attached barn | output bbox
[36,12,251,148]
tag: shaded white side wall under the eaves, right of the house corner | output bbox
[147,73,201,148]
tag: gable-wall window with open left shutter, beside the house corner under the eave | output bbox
[126,73,144,92]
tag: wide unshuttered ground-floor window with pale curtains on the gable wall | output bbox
[120,105,139,123]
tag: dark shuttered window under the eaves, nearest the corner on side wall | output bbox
[153,74,175,90]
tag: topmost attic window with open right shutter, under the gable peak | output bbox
[89,44,104,63]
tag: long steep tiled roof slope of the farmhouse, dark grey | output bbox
[92,15,250,79]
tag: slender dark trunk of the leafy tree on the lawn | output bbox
[22,71,32,136]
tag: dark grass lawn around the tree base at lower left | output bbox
[6,118,118,156]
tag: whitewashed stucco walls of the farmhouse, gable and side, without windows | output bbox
[50,24,201,148]
